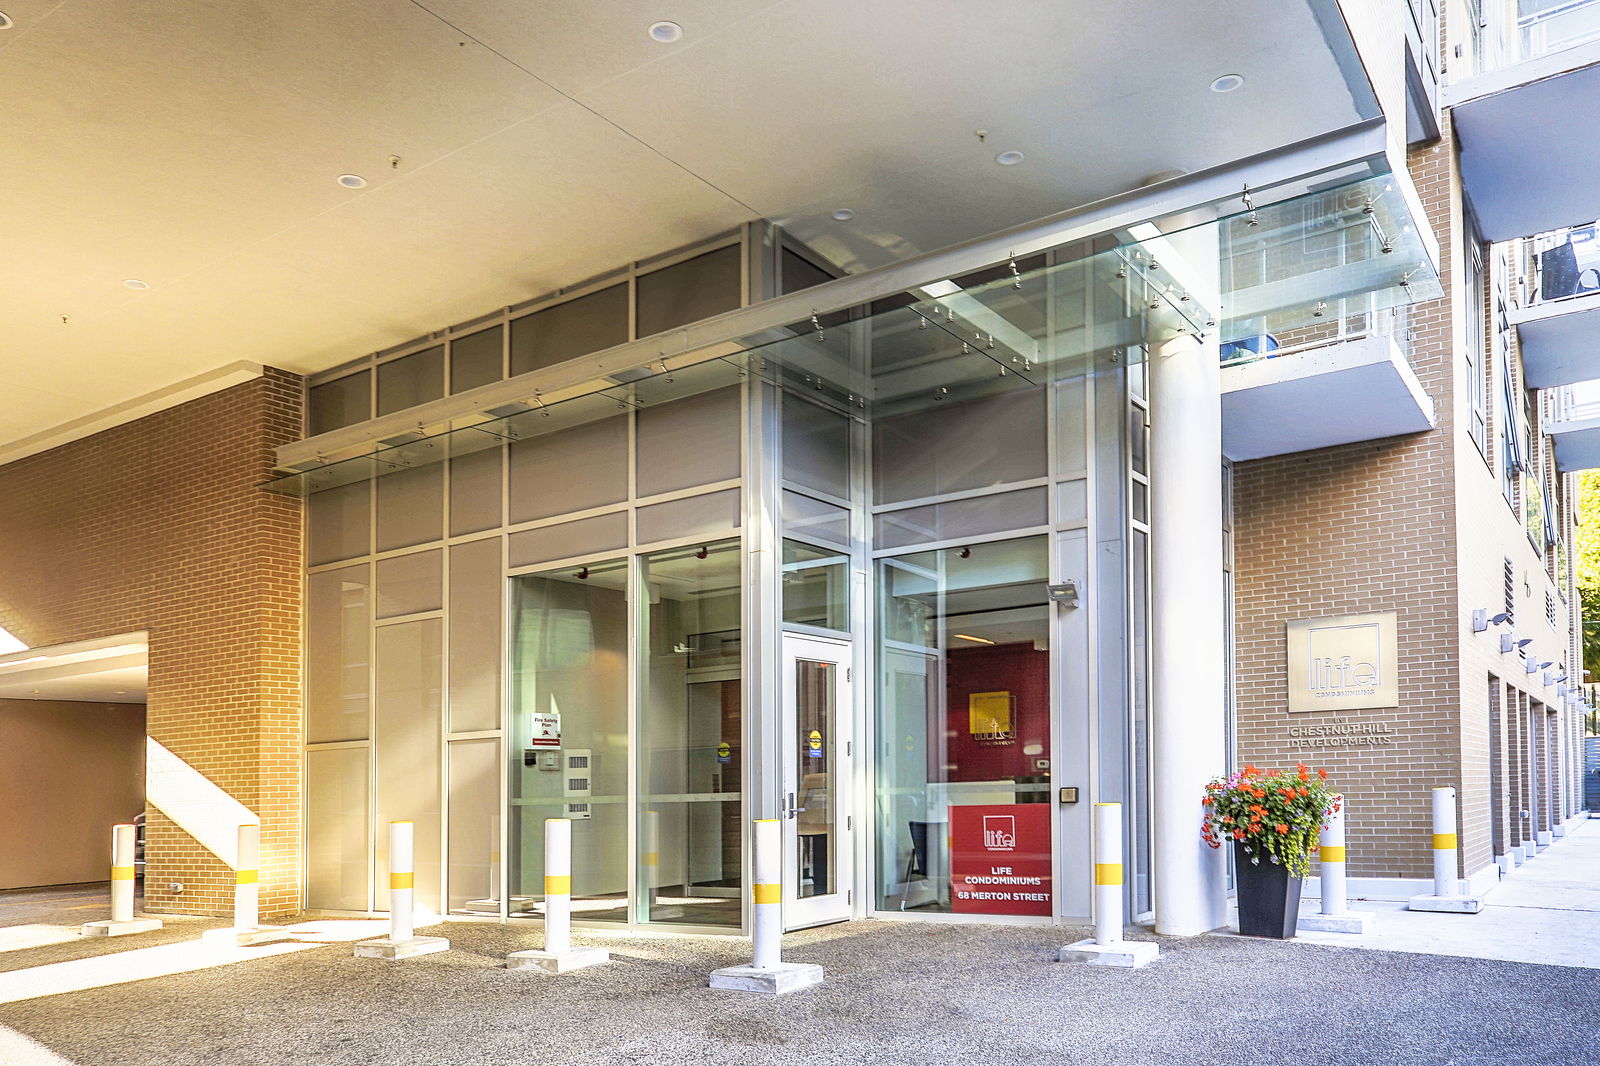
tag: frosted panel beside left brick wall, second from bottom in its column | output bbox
[306,563,370,744]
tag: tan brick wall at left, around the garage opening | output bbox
[0,370,301,914]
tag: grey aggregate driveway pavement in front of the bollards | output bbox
[0,893,1600,1066]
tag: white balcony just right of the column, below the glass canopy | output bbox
[1222,299,1437,461]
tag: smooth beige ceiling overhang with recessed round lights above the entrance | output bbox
[0,0,1371,447]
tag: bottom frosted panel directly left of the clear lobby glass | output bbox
[446,739,501,914]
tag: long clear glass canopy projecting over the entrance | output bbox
[266,178,1442,495]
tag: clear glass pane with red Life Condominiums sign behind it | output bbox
[877,536,1051,916]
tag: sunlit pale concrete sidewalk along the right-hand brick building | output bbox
[1294,820,1600,960]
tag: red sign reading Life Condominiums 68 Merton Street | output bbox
[950,804,1051,917]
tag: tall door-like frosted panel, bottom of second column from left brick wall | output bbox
[373,618,443,914]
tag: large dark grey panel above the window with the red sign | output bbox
[872,389,1046,503]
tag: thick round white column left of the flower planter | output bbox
[1149,321,1227,936]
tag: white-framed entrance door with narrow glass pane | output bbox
[781,634,856,928]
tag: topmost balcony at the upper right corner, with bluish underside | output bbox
[1445,0,1600,242]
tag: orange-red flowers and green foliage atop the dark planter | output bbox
[1200,762,1338,877]
